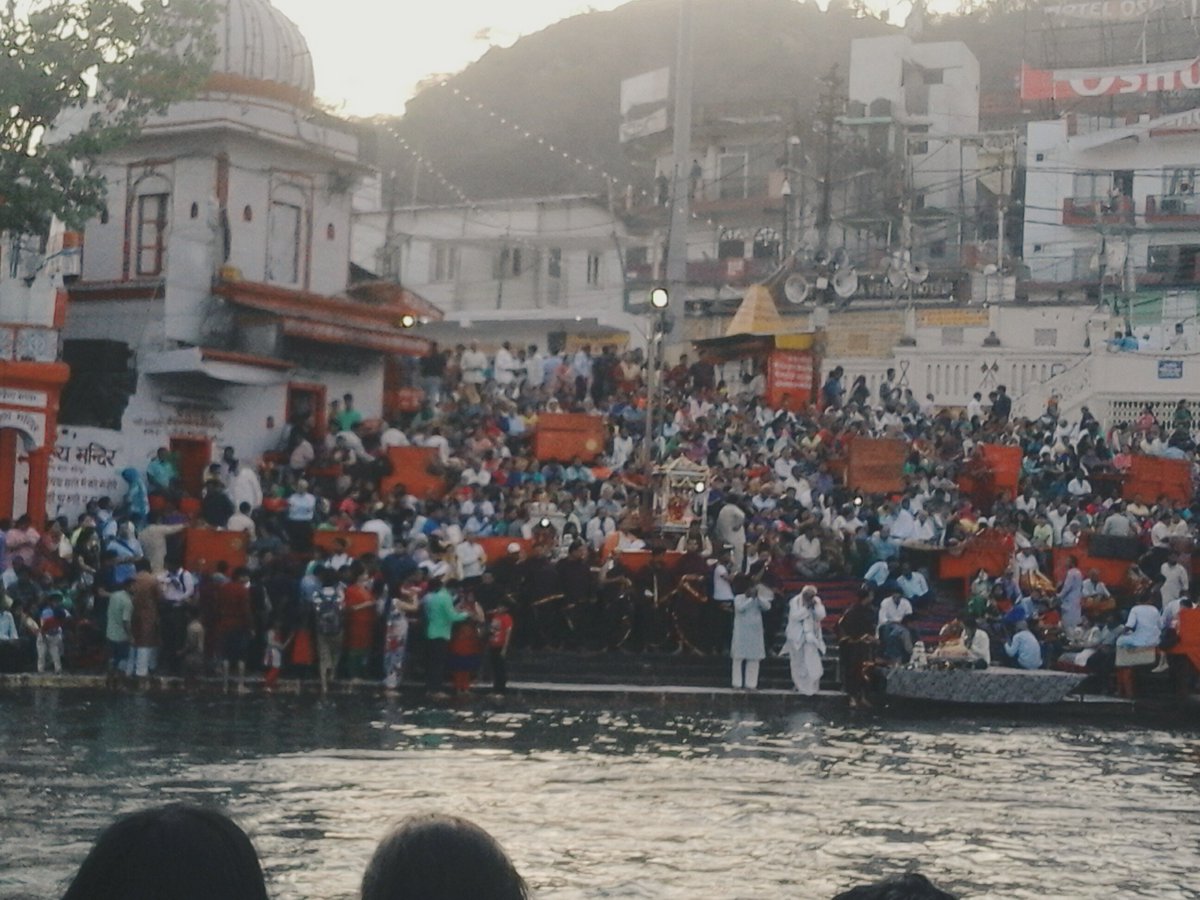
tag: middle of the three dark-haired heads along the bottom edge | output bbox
[362,814,529,900]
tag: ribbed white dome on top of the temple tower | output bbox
[212,0,313,102]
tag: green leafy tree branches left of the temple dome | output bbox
[0,0,215,234]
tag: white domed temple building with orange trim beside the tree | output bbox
[49,0,437,512]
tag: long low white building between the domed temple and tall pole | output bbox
[353,192,642,352]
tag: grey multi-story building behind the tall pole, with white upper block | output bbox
[625,35,980,336]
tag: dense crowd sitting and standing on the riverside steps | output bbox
[0,342,1200,703]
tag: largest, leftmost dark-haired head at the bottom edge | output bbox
[62,804,266,900]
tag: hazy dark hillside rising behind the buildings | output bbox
[360,0,892,203]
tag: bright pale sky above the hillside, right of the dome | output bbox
[271,0,921,115]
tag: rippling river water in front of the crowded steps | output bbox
[0,690,1200,900]
